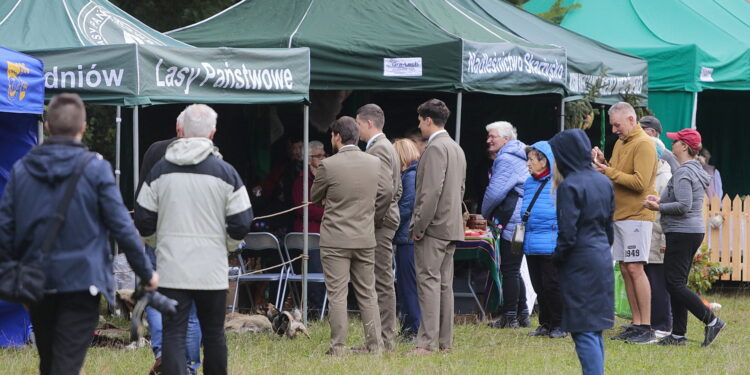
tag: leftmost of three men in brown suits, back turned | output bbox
[310,116,383,355]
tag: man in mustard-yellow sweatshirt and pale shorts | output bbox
[591,102,657,344]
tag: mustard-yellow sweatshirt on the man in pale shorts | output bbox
[604,125,657,221]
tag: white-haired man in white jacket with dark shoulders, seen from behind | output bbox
[135,104,253,375]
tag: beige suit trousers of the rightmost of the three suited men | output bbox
[414,235,456,351]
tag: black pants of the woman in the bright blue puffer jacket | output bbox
[526,255,563,329]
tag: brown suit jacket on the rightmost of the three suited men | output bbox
[410,133,466,241]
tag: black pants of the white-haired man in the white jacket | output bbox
[159,288,227,375]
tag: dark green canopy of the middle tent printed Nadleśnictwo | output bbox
[168,0,567,95]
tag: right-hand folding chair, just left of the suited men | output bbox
[281,232,328,320]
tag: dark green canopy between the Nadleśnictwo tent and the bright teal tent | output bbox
[444,0,648,104]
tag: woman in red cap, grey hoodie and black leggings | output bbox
[643,129,726,346]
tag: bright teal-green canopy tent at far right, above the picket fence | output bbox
[526,0,750,194]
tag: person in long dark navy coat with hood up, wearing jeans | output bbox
[549,129,615,375]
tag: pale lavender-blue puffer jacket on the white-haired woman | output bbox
[482,140,529,240]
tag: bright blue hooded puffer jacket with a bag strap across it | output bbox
[520,141,557,255]
